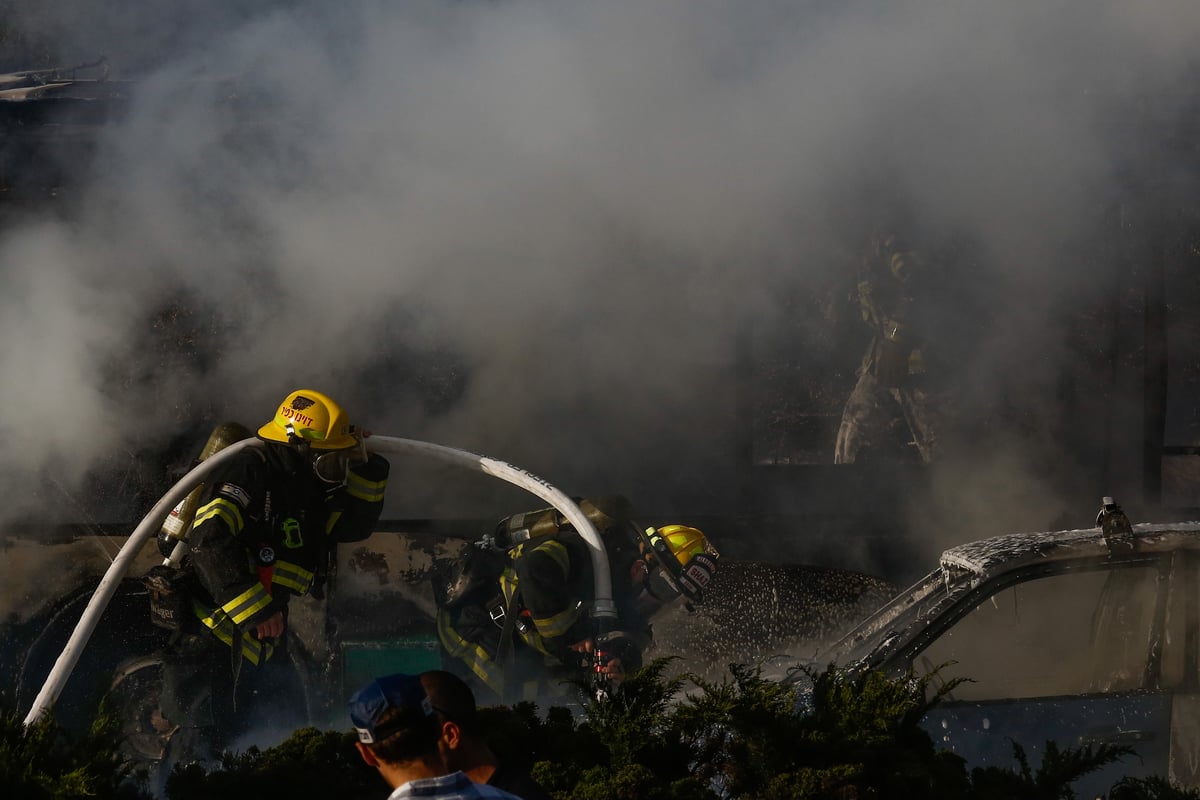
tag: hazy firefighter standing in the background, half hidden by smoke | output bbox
[834,234,938,464]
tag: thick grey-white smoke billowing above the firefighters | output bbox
[0,0,1200,544]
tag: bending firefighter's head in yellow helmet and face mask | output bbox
[635,525,720,616]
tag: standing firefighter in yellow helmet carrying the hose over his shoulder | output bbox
[154,390,389,759]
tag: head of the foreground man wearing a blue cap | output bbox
[348,673,448,780]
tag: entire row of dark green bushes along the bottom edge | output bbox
[0,660,1171,800]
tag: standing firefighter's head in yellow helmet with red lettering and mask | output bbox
[258,389,367,486]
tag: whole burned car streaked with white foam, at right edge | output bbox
[823,498,1200,796]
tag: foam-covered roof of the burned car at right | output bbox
[940,522,1200,579]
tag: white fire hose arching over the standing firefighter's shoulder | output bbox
[25,435,617,727]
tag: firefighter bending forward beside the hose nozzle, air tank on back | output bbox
[438,497,719,703]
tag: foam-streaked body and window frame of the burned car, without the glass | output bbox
[823,522,1200,796]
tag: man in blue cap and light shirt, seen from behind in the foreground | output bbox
[349,673,521,800]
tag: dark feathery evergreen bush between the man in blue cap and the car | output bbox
[511,660,1137,800]
